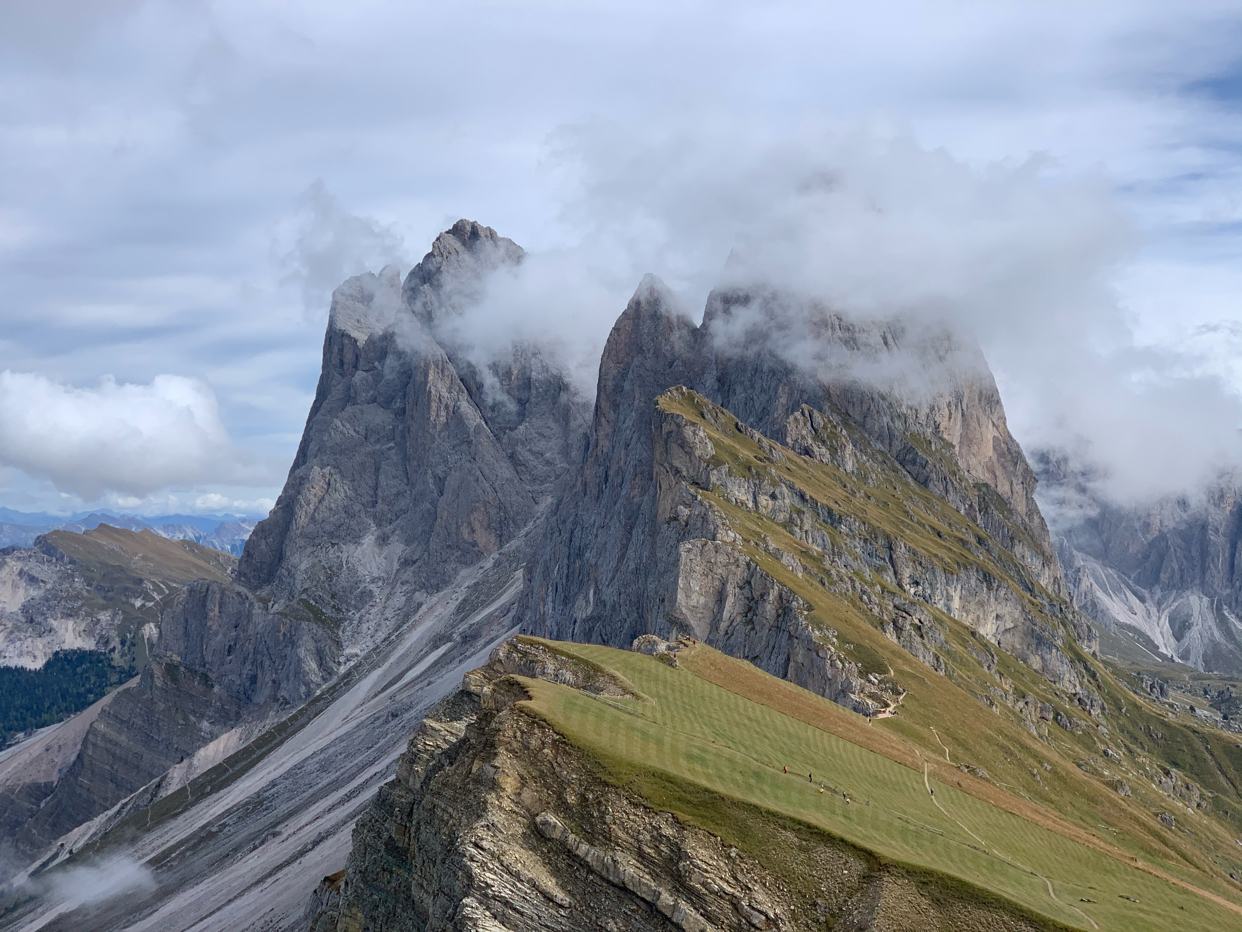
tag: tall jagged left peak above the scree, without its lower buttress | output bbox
[238,220,585,640]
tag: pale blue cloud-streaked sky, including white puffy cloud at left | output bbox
[0,0,1242,513]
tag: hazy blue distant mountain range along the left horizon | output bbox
[0,508,256,557]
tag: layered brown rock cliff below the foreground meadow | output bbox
[306,641,1058,932]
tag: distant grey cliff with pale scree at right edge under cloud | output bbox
[1036,451,1242,675]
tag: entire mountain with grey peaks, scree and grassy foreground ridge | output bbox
[0,220,1242,932]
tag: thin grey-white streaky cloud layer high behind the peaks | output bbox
[0,0,1242,519]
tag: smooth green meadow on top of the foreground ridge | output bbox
[524,644,1242,932]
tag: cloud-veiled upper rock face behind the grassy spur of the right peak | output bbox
[692,291,1062,593]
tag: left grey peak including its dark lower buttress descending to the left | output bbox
[0,220,586,889]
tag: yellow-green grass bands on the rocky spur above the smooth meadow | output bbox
[658,389,1242,900]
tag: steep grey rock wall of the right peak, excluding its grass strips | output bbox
[522,278,1092,711]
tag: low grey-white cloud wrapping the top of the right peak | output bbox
[442,121,1242,511]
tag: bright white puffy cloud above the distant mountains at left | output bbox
[0,369,252,501]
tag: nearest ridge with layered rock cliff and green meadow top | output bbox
[311,637,1242,932]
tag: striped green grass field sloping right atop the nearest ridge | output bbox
[523,642,1242,932]
